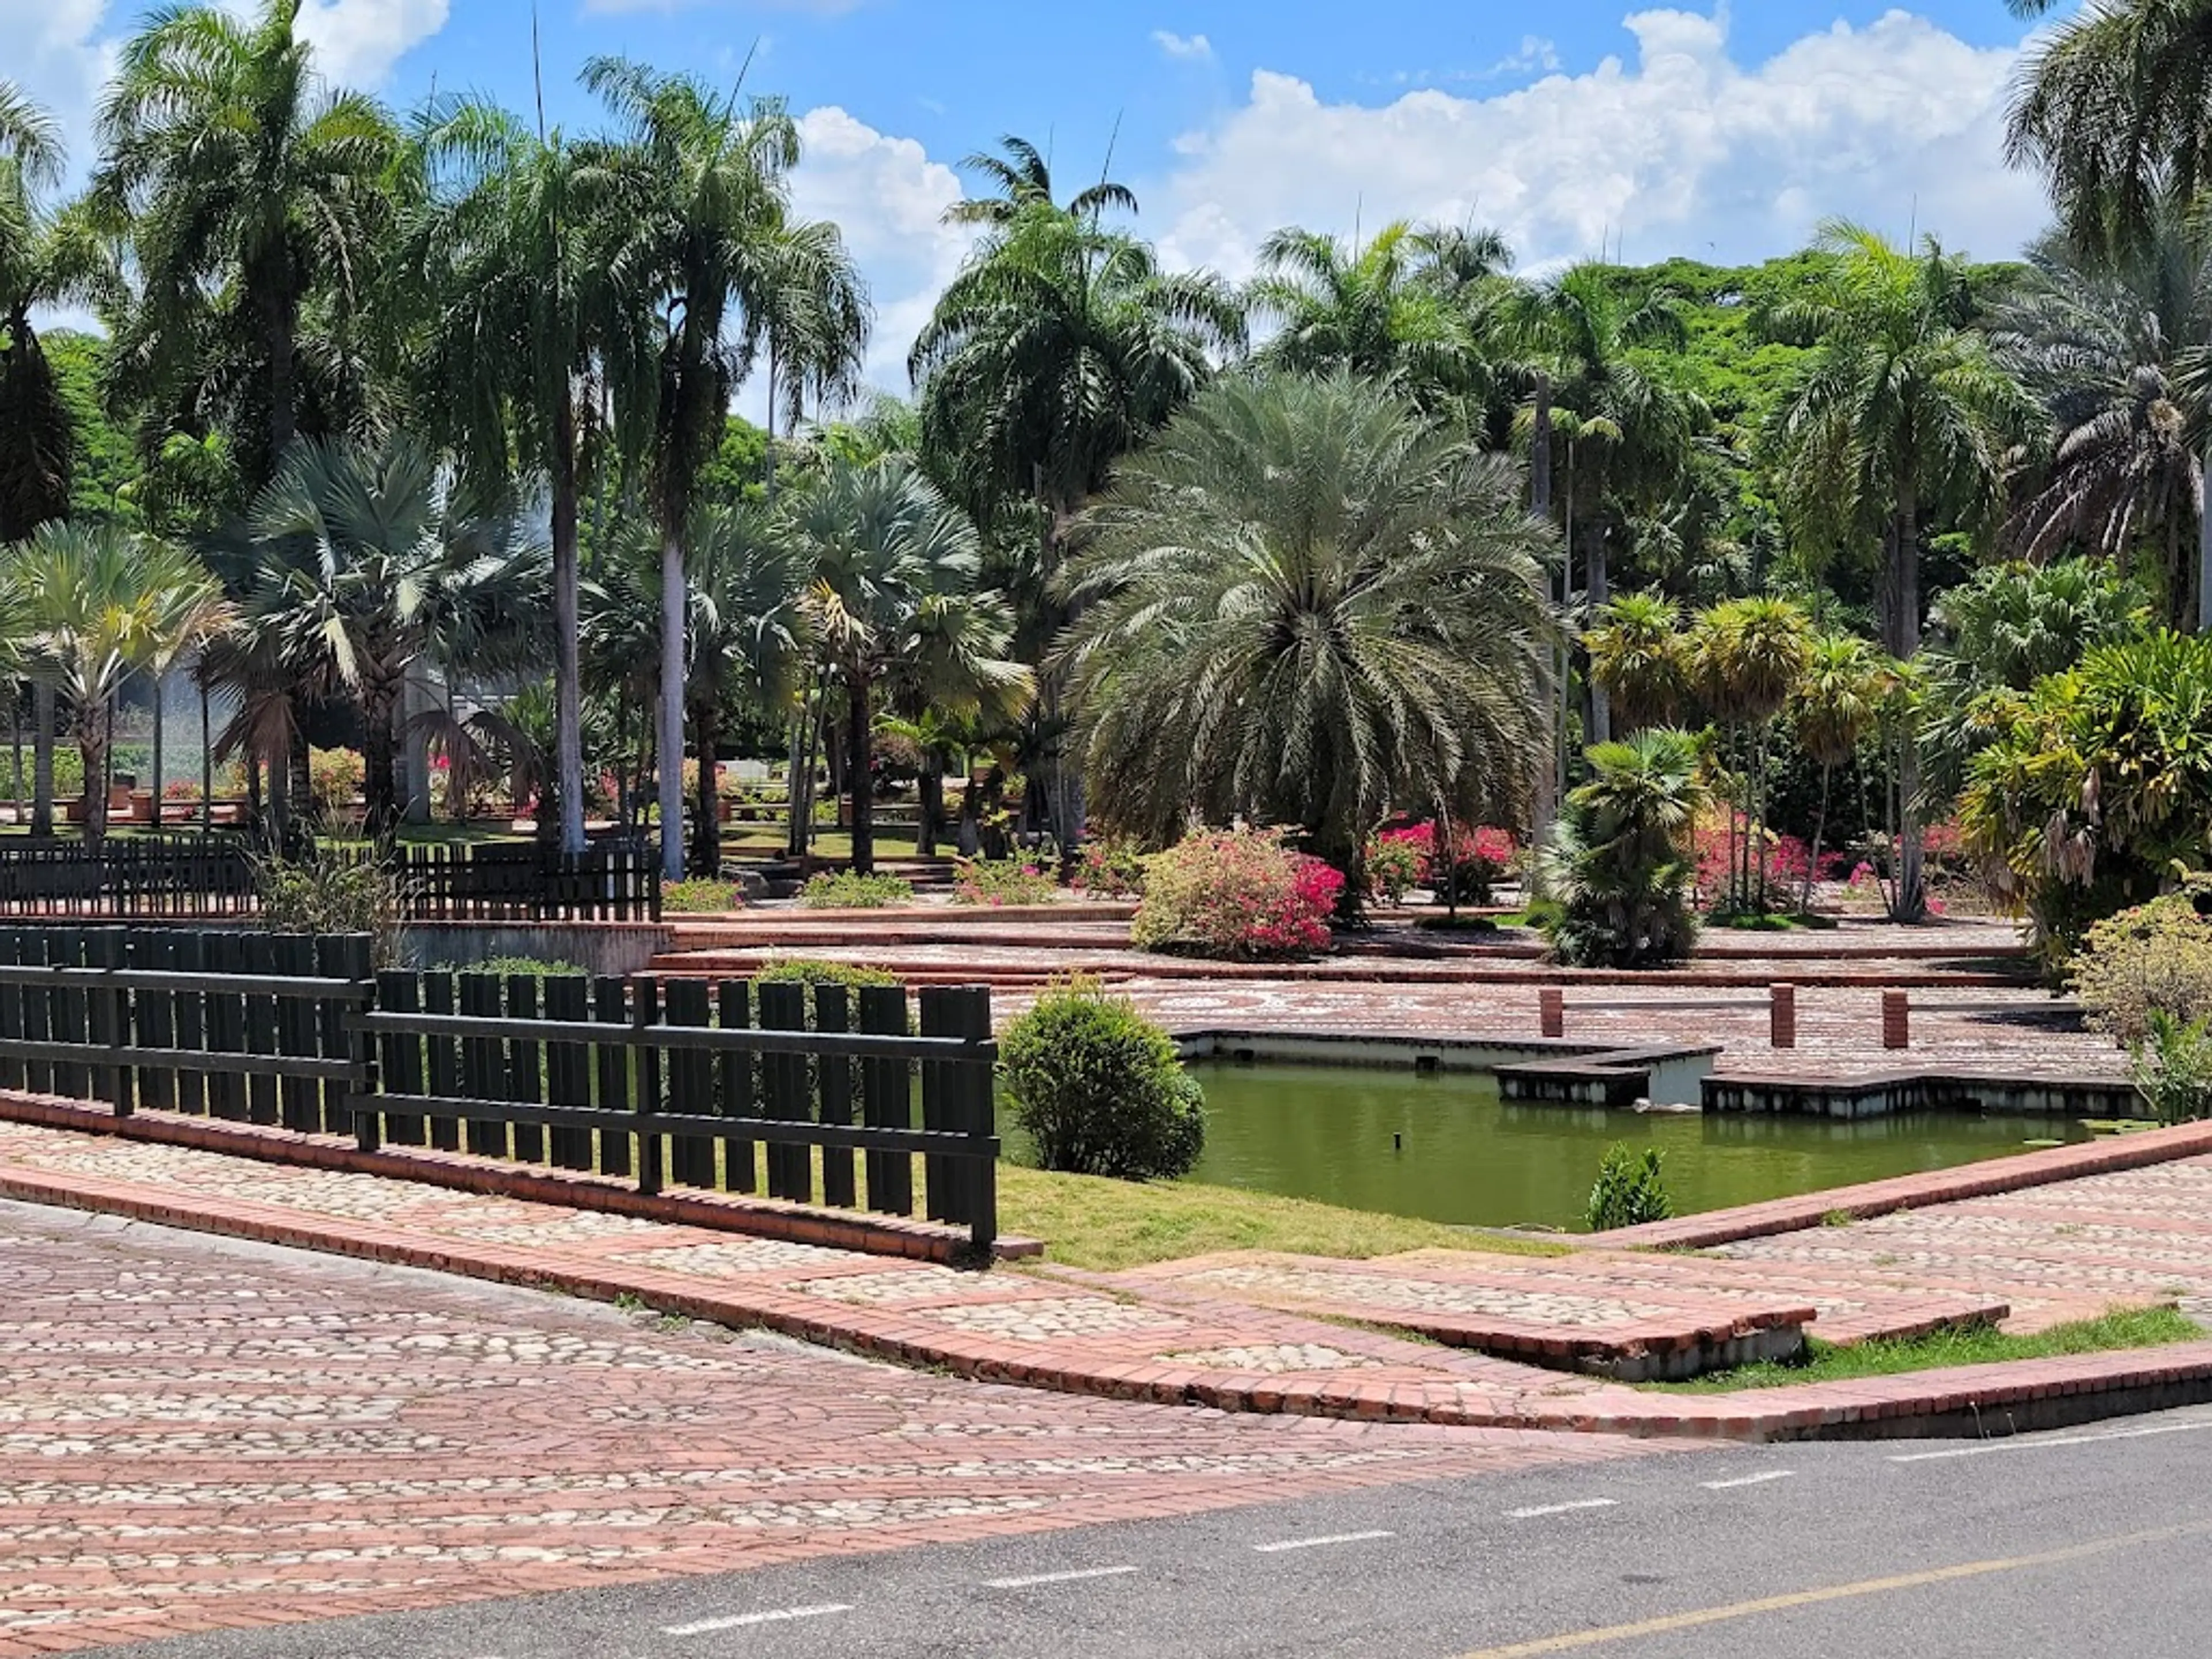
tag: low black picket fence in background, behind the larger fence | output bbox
[0,836,661,922]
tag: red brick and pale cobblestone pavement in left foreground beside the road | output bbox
[0,1203,1633,1657]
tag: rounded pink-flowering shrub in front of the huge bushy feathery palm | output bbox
[1130,830,1345,962]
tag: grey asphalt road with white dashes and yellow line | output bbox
[111,1409,2212,1659]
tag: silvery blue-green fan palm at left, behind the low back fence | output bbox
[243,440,546,836]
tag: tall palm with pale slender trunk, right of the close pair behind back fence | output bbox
[584,58,818,878]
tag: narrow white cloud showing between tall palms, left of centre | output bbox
[783,106,974,402]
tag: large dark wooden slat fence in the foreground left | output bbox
[0,927,998,1254]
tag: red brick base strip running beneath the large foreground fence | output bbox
[0,1090,1044,1263]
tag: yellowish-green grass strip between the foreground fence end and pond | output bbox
[998,1164,1566,1272]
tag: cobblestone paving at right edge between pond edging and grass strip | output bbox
[1717,1157,2212,1327]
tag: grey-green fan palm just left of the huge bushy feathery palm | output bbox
[790,456,1029,874]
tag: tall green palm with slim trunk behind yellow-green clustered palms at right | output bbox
[1767,224,2033,920]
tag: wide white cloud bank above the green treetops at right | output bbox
[1143,7,2044,276]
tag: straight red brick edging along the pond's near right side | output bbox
[1601,1122,2212,1250]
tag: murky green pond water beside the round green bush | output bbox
[1190,1064,2088,1228]
